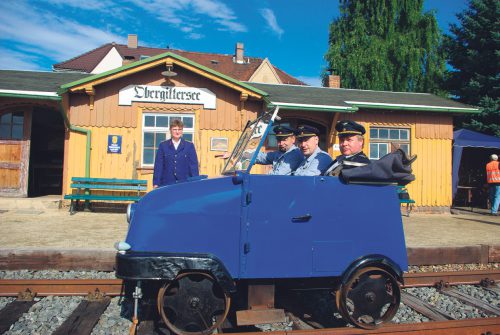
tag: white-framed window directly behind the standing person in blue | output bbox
[142,113,194,167]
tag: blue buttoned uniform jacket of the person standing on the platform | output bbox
[153,138,199,186]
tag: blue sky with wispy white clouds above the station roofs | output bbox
[0,0,467,85]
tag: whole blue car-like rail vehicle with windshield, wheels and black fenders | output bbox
[116,108,407,335]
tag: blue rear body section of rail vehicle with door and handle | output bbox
[240,175,407,278]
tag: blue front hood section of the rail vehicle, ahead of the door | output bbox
[126,177,241,275]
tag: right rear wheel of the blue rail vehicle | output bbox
[336,267,401,329]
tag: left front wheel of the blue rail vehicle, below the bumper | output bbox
[157,272,231,335]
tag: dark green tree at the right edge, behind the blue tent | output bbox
[445,0,500,136]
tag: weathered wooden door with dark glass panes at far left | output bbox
[0,110,31,197]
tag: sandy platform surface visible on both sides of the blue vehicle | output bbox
[0,209,500,250]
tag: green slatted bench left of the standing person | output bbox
[64,177,147,214]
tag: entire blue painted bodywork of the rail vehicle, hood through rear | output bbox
[126,172,407,279]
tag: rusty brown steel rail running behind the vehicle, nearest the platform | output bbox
[0,270,500,297]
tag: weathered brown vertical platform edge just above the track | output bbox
[0,245,500,271]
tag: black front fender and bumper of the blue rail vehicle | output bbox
[115,251,236,293]
